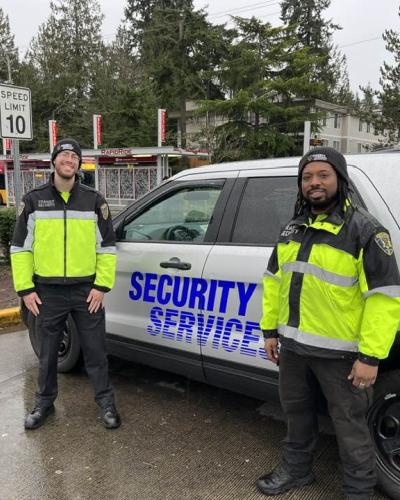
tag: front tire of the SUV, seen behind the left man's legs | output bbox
[21,301,82,373]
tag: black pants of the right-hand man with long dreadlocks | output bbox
[279,349,376,500]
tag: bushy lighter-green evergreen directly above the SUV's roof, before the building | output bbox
[200,18,320,161]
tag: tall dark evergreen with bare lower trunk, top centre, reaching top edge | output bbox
[126,0,231,147]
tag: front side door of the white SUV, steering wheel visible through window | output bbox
[107,173,237,357]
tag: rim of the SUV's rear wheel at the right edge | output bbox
[368,394,400,484]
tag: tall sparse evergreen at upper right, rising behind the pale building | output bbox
[281,0,354,104]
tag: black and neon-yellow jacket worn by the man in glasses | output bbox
[11,175,116,296]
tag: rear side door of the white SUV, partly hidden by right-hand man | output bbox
[202,168,297,385]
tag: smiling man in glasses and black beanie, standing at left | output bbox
[11,139,121,429]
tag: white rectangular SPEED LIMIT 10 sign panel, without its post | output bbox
[0,85,32,140]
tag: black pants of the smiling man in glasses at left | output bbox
[36,283,114,408]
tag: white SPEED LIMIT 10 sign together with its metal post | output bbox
[0,85,32,213]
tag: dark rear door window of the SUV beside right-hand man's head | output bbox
[232,177,297,245]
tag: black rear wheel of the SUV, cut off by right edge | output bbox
[368,370,400,498]
